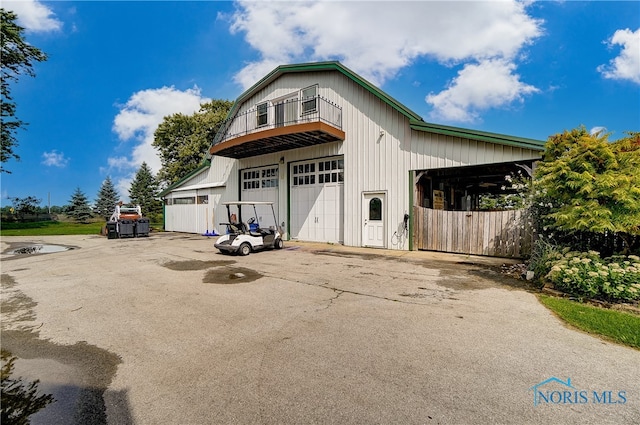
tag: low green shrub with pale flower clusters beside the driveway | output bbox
[546,250,640,302]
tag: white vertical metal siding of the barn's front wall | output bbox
[174,67,540,249]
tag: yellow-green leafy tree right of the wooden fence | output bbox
[534,127,640,249]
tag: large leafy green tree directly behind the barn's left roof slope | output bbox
[153,100,233,185]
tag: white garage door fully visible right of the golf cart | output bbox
[290,157,344,243]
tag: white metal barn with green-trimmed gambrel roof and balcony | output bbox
[161,62,543,250]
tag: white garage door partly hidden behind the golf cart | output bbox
[240,165,278,225]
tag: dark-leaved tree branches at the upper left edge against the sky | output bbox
[0,8,47,173]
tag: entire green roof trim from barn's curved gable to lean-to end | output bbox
[215,61,545,151]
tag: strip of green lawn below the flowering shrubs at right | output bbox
[540,295,640,349]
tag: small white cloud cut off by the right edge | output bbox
[598,28,640,84]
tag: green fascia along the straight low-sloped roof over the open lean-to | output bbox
[409,120,545,152]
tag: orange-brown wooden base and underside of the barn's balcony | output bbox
[209,121,345,159]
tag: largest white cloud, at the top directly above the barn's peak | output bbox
[230,0,541,88]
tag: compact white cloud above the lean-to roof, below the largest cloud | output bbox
[425,59,539,122]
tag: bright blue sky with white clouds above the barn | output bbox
[0,0,640,206]
